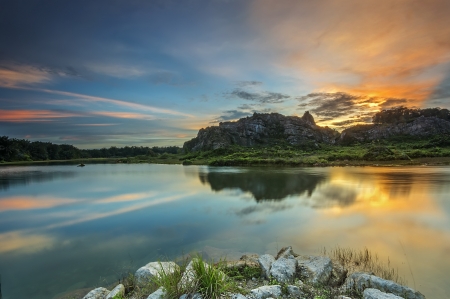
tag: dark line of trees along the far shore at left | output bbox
[0,136,181,162]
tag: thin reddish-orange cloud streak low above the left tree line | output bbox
[0,109,83,122]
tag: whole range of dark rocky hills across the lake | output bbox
[183,107,450,152]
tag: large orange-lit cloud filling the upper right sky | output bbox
[251,0,450,104]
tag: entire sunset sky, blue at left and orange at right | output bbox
[0,0,450,148]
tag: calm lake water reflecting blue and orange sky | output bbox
[0,164,450,299]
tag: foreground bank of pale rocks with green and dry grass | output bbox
[74,246,425,299]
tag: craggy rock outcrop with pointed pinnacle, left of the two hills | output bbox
[183,112,339,152]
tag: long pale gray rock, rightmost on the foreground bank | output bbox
[343,273,425,299]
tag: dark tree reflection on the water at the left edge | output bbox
[0,171,75,190]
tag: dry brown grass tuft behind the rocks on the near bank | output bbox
[322,247,407,285]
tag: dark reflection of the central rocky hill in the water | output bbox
[199,170,326,201]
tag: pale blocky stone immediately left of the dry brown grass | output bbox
[295,256,333,284]
